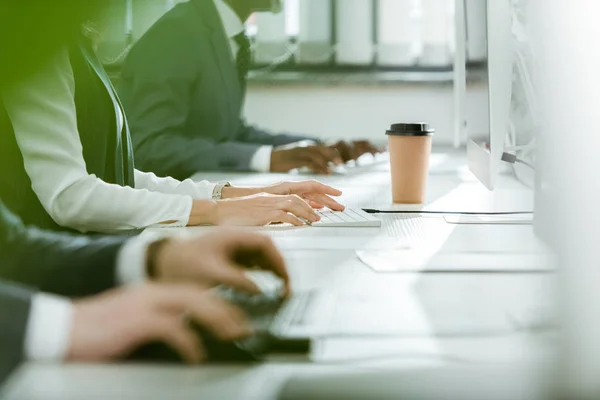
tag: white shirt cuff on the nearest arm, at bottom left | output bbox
[25,293,73,361]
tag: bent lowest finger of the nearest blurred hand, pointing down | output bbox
[147,314,204,364]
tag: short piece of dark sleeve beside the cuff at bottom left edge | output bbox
[0,281,34,387]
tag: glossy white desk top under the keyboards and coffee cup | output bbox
[5,155,554,400]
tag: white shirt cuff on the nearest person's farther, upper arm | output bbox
[117,232,160,285]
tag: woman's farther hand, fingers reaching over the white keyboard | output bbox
[262,181,344,211]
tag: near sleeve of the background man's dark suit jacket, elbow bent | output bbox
[119,19,270,179]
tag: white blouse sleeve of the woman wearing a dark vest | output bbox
[2,49,192,232]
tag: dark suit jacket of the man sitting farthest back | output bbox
[118,0,308,179]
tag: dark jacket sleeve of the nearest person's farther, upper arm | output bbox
[0,202,126,297]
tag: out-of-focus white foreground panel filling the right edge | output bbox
[529,0,600,399]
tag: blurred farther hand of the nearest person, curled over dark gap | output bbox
[152,230,290,295]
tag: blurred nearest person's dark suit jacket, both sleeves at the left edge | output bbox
[0,202,125,384]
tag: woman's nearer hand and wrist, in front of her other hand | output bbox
[210,189,320,226]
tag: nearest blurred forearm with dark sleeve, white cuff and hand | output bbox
[0,282,252,376]
